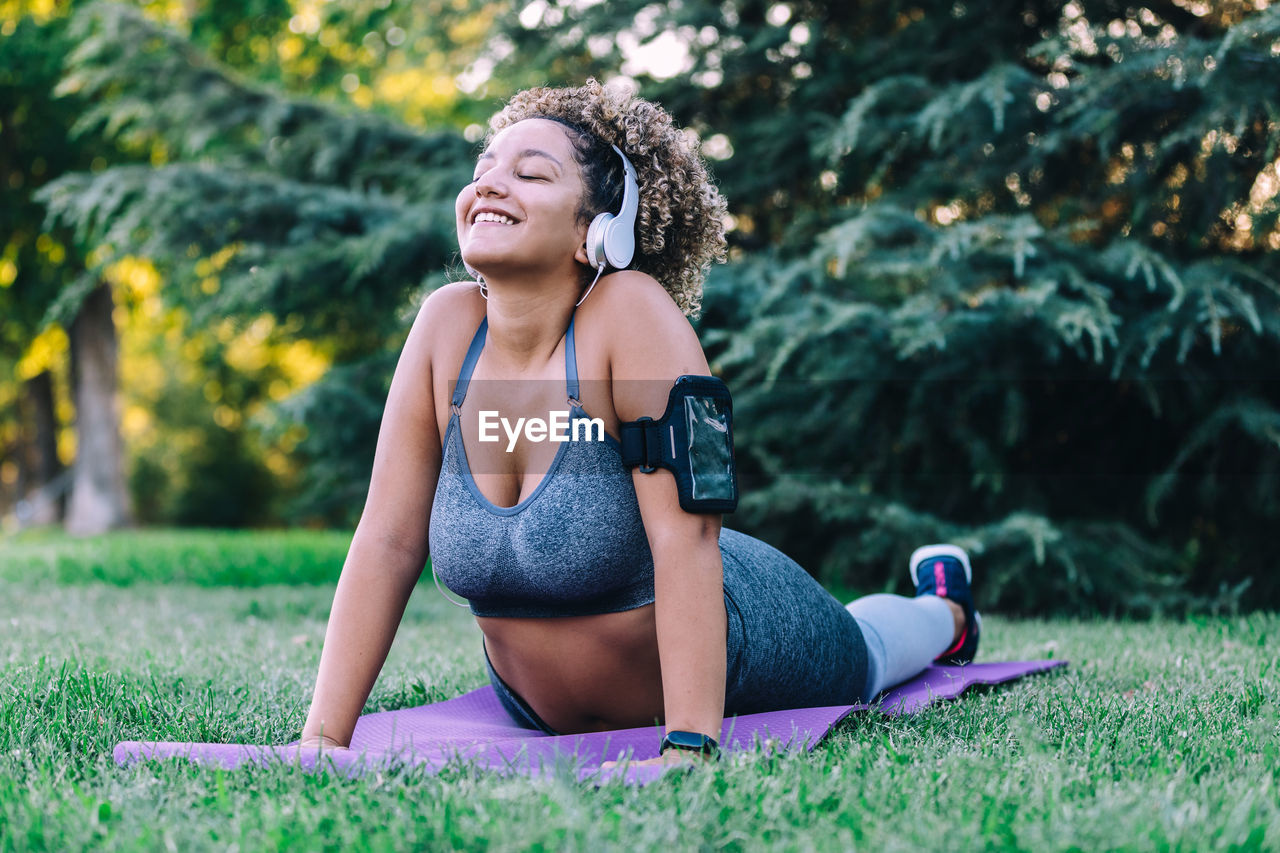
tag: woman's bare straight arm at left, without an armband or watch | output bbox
[302,285,456,747]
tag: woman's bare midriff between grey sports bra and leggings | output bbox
[476,605,663,734]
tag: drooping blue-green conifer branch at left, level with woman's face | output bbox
[41,165,456,329]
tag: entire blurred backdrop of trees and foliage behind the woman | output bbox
[0,0,1280,613]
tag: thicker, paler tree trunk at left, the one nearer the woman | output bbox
[67,284,129,535]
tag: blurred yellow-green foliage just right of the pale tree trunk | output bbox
[106,257,329,526]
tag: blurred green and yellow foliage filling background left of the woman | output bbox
[0,0,490,525]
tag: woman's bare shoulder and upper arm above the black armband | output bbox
[591,270,710,420]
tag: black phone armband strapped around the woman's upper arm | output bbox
[618,377,737,512]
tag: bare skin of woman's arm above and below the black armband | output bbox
[599,273,726,740]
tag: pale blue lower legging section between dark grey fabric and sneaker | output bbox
[845,593,956,698]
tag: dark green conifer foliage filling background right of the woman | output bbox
[481,0,1280,611]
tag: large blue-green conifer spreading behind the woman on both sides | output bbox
[35,0,1280,611]
